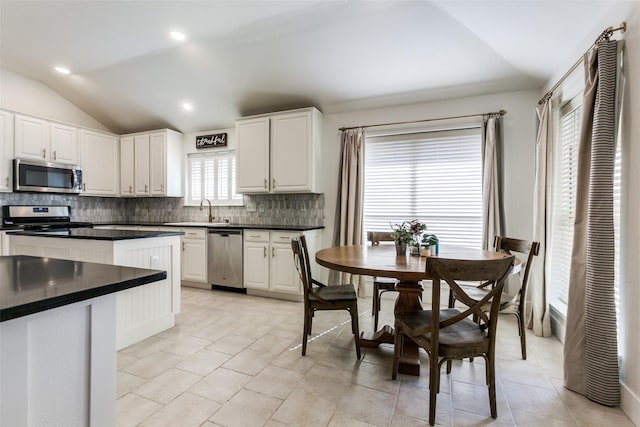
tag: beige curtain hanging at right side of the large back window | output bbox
[482,116,504,249]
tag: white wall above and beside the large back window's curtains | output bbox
[321,91,539,252]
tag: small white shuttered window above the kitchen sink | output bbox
[184,150,244,206]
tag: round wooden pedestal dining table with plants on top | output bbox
[316,244,519,375]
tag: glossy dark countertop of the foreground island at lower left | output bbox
[0,255,167,322]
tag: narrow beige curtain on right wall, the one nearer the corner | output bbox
[527,98,553,337]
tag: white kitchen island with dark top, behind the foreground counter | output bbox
[8,228,183,350]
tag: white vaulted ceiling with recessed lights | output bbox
[0,0,617,133]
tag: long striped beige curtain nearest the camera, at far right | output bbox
[564,40,621,406]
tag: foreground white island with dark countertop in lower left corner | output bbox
[0,256,167,426]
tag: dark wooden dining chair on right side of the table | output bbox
[449,236,540,360]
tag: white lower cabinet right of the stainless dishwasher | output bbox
[243,229,318,300]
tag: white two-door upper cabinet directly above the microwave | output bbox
[15,114,78,164]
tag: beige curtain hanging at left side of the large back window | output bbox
[329,129,365,297]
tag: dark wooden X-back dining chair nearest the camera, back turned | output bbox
[391,255,515,425]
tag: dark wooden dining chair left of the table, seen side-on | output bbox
[291,235,360,359]
